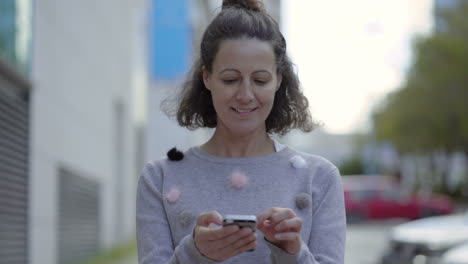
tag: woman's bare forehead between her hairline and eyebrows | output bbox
[213,38,276,72]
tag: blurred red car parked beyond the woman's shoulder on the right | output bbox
[343,175,453,222]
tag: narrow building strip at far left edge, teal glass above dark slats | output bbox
[0,0,31,264]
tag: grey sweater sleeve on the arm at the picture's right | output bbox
[265,167,346,264]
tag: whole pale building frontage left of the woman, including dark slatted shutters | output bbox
[0,0,148,264]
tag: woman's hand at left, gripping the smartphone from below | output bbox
[194,211,257,261]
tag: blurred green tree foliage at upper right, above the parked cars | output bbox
[373,1,468,153]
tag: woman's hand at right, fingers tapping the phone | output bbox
[257,207,302,254]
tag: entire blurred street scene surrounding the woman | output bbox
[0,0,468,264]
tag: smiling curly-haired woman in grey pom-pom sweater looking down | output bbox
[137,0,346,264]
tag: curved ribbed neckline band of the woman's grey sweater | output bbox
[188,146,292,164]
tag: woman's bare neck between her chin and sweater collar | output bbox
[201,128,275,158]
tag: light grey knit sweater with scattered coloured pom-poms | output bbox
[136,147,346,264]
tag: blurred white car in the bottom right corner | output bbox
[381,211,468,264]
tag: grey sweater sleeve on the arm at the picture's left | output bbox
[136,164,216,264]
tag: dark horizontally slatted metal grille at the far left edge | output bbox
[0,83,29,264]
